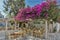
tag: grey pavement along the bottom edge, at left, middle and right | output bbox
[0,31,60,40]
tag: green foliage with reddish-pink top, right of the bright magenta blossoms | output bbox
[48,0,58,21]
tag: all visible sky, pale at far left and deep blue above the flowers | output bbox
[0,0,60,15]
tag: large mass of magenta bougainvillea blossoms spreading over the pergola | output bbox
[15,1,55,21]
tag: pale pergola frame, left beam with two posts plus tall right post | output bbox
[0,18,48,39]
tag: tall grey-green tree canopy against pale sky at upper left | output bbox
[3,0,25,16]
